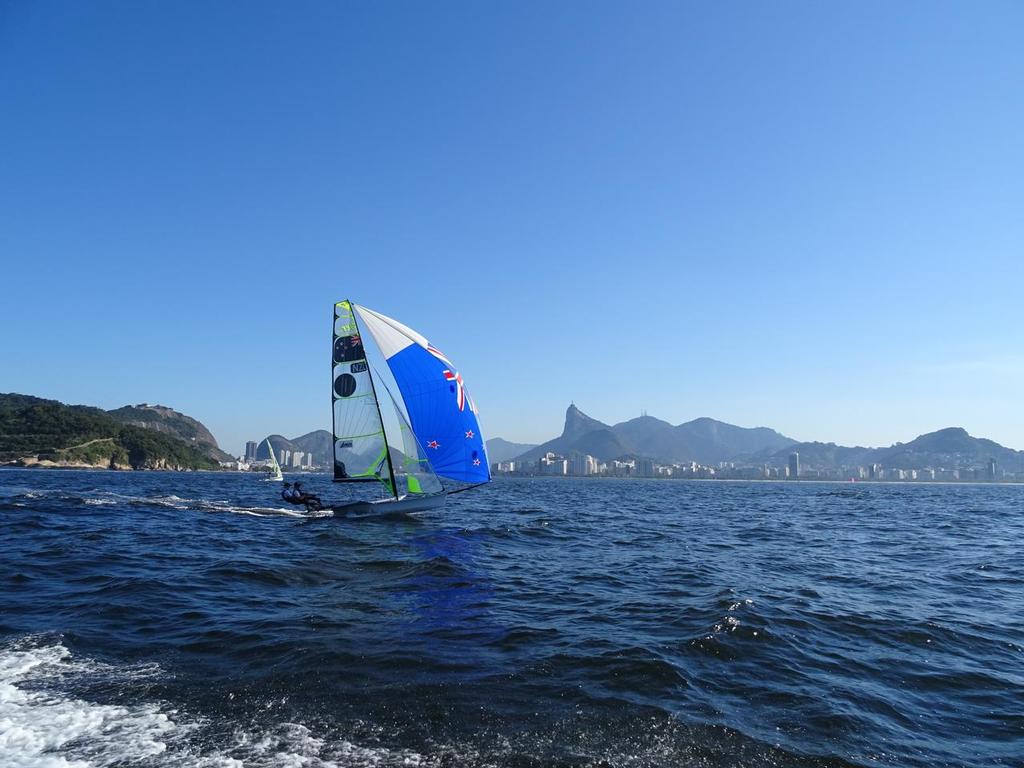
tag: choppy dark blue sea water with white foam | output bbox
[0,471,1024,768]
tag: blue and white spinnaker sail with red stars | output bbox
[353,305,490,484]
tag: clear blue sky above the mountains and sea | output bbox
[0,0,1024,452]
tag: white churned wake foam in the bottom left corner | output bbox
[0,637,425,768]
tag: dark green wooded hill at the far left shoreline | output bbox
[0,393,219,469]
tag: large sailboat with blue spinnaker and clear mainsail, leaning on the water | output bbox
[332,300,490,515]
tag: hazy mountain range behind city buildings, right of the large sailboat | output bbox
[503,404,1024,472]
